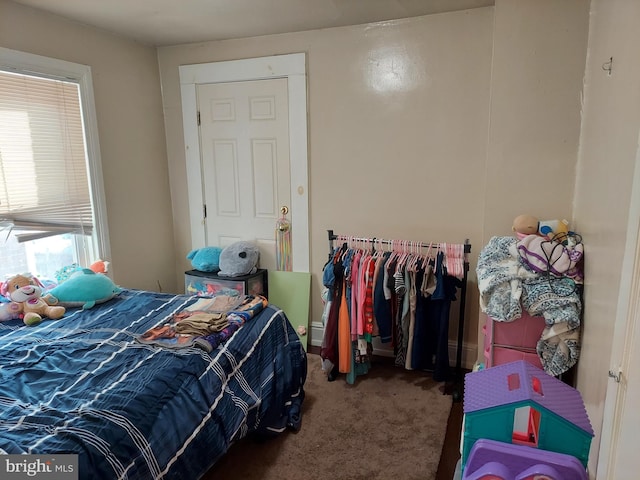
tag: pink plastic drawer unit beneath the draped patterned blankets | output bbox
[482,311,545,368]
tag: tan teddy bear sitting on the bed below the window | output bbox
[2,275,65,325]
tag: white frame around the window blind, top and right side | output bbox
[0,47,111,266]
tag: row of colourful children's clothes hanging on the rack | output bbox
[320,231,470,383]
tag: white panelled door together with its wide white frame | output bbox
[180,53,309,272]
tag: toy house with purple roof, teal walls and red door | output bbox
[461,360,593,469]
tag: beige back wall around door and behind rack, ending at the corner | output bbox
[158,7,493,362]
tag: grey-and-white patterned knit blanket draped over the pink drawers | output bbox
[476,237,582,376]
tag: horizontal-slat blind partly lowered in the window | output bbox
[0,71,93,241]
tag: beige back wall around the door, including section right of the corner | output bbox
[158,0,588,362]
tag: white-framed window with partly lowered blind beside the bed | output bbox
[0,48,109,280]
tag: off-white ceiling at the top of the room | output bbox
[13,0,494,47]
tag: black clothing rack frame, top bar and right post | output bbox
[327,230,471,401]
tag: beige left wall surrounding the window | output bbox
[0,0,176,291]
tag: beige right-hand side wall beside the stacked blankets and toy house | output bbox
[574,0,640,478]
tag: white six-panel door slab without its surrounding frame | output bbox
[197,78,291,270]
